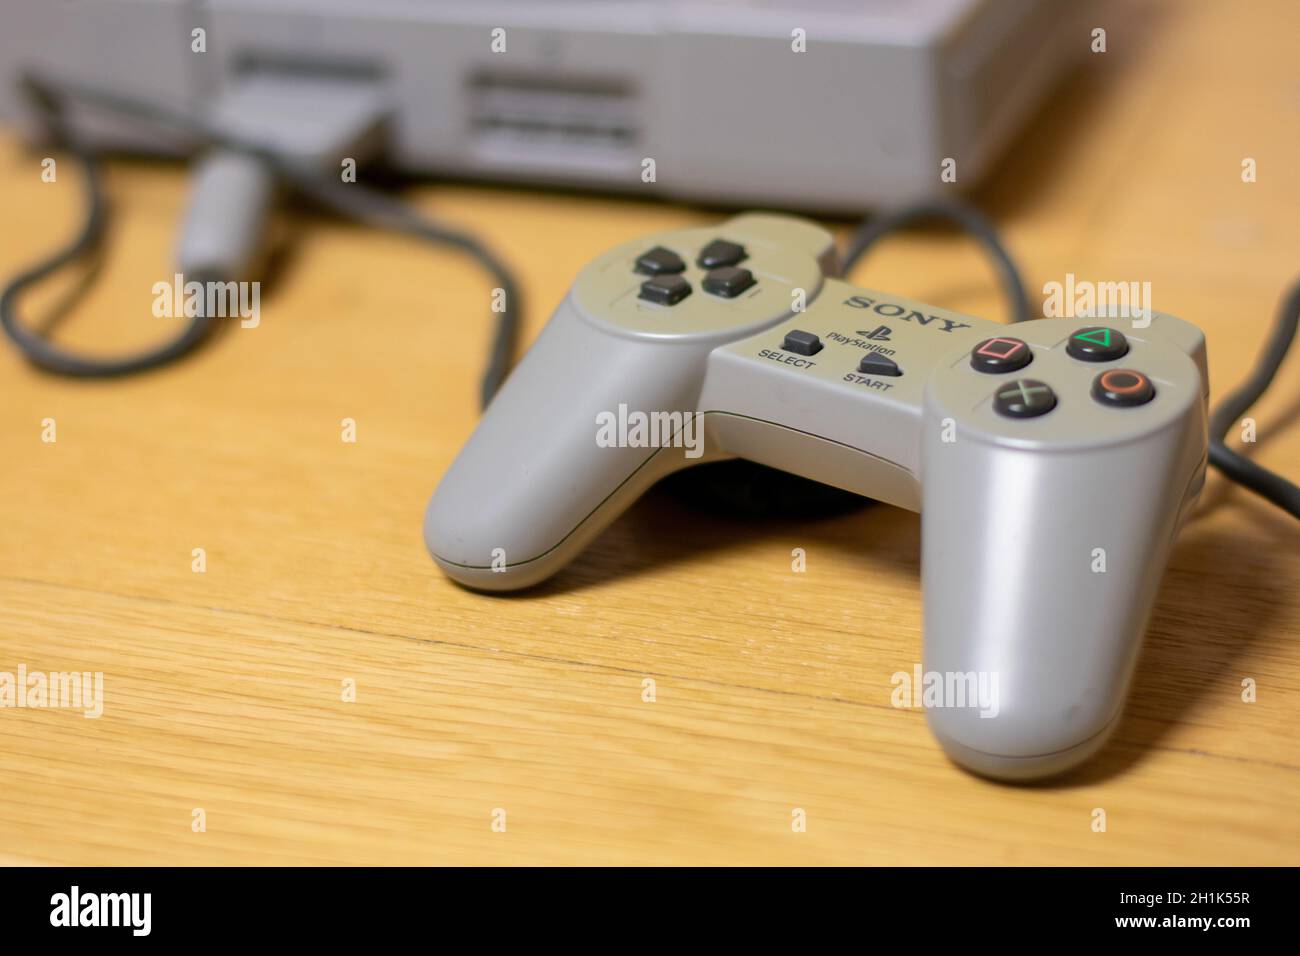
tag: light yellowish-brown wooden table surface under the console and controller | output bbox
[0,0,1300,864]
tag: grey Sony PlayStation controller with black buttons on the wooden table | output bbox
[424,215,1208,779]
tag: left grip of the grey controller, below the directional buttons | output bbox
[424,298,711,591]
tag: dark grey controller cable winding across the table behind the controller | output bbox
[0,75,1300,518]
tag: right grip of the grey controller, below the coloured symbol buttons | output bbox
[922,403,1205,779]
